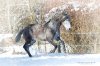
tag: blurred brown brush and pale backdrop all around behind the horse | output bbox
[0,0,100,54]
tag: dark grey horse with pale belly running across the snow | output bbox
[16,12,70,57]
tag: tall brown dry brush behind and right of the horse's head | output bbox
[13,0,100,53]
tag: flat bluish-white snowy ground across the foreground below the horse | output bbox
[0,53,100,66]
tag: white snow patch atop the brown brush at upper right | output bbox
[68,1,100,13]
